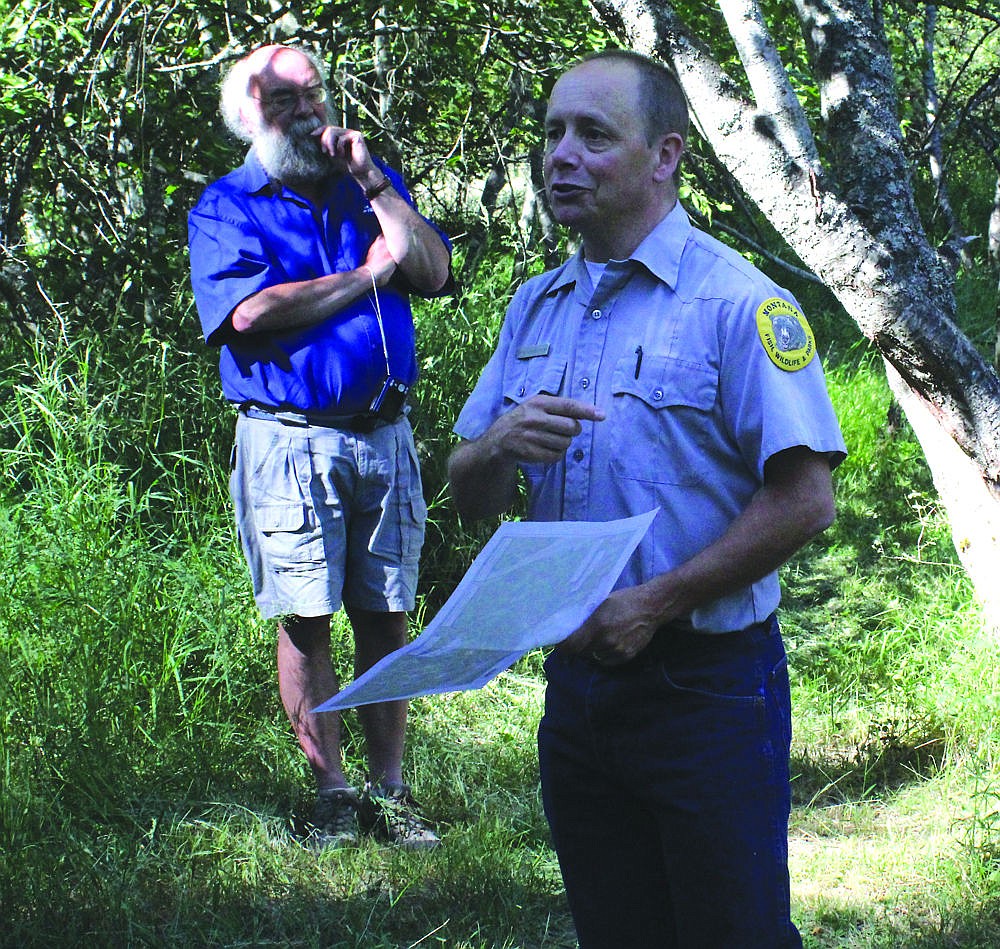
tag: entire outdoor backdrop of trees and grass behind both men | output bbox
[0,0,1000,949]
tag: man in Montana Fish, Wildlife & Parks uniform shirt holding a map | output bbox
[450,51,845,949]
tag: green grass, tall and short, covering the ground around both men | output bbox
[0,306,1000,949]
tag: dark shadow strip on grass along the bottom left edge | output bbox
[0,872,576,949]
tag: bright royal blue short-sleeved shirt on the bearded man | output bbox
[188,151,447,415]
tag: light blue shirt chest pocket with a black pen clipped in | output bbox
[604,354,718,485]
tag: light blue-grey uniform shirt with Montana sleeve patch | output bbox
[455,205,846,632]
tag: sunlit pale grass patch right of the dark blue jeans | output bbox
[790,762,1000,949]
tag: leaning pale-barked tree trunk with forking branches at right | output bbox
[591,0,1000,627]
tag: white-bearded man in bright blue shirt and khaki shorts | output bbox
[189,45,451,849]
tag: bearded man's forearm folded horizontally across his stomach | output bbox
[231,265,372,333]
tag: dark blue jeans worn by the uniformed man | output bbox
[538,619,802,949]
